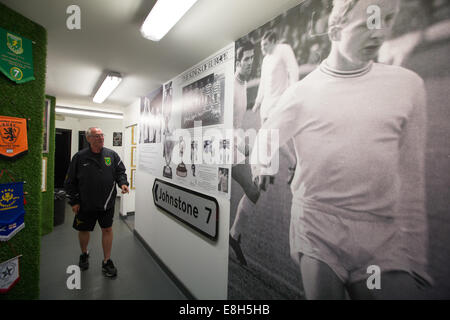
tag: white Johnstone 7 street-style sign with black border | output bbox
[153,179,219,240]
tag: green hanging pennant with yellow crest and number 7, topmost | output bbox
[0,28,35,83]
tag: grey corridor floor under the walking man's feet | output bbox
[40,199,186,300]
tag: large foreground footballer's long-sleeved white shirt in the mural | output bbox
[252,62,427,276]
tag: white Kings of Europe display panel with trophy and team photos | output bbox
[139,45,234,198]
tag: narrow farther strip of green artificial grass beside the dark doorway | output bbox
[41,96,56,235]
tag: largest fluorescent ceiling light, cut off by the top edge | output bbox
[141,0,197,41]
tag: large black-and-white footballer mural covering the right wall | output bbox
[228,0,450,299]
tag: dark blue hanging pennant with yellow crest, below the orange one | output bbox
[0,182,25,241]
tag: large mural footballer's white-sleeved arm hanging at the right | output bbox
[398,80,428,282]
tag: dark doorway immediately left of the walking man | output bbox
[55,128,72,188]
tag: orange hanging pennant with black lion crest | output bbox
[0,116,28,158]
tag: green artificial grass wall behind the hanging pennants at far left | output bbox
[0,3,47,299]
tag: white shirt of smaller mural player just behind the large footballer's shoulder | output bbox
[255,44,299,120]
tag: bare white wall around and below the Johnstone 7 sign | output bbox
[135,171,230,300]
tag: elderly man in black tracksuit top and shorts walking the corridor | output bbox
[65,127,129,277]
